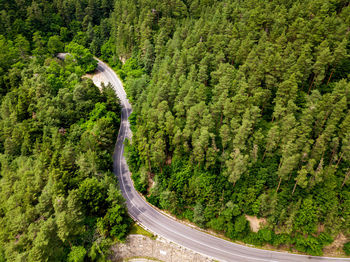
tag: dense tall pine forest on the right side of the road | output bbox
[115,0,350,255]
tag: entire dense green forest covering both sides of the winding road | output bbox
[0,0,350,261]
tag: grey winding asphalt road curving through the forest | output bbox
[97,58,350,262]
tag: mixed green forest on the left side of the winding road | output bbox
[0,1,131,262]
